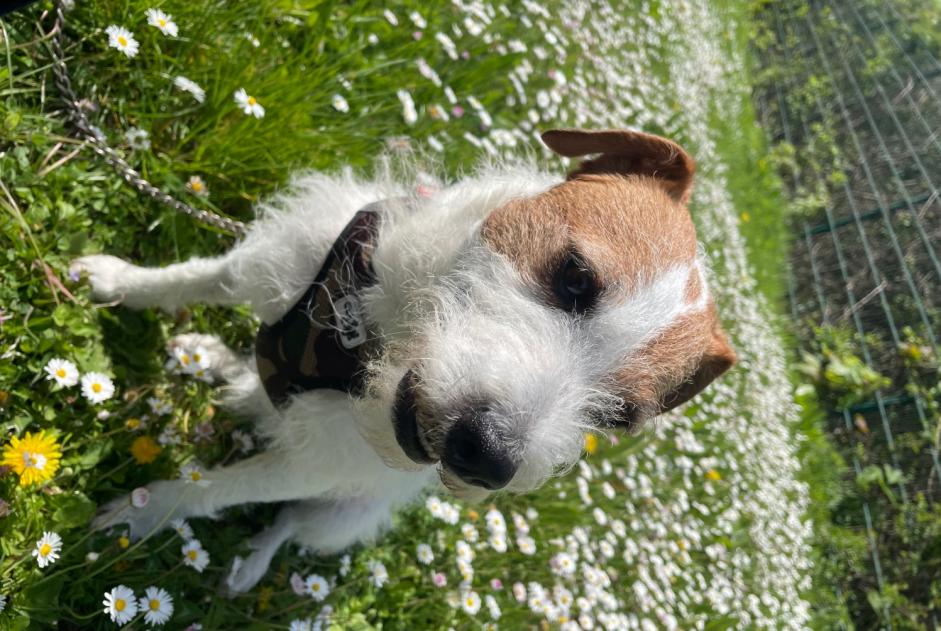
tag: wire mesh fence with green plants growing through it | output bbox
[755,0,941,629]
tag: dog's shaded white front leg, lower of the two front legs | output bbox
[92,451,331,540]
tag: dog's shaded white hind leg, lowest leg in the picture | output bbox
[226,498,392,594]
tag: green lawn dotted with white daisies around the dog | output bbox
[0,0,815,629]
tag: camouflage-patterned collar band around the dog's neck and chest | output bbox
[255,202,383,407]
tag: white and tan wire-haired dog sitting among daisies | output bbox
[75,129,736,592]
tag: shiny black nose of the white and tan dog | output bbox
[443,410,517,491]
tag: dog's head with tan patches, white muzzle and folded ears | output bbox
[363,130,735,498]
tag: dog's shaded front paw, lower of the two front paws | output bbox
[91,480,183,541]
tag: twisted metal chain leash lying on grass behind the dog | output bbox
[52,0,245,236]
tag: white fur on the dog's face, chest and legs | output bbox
[77,162,705,591]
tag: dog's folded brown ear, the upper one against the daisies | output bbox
[542,129,696,204]
